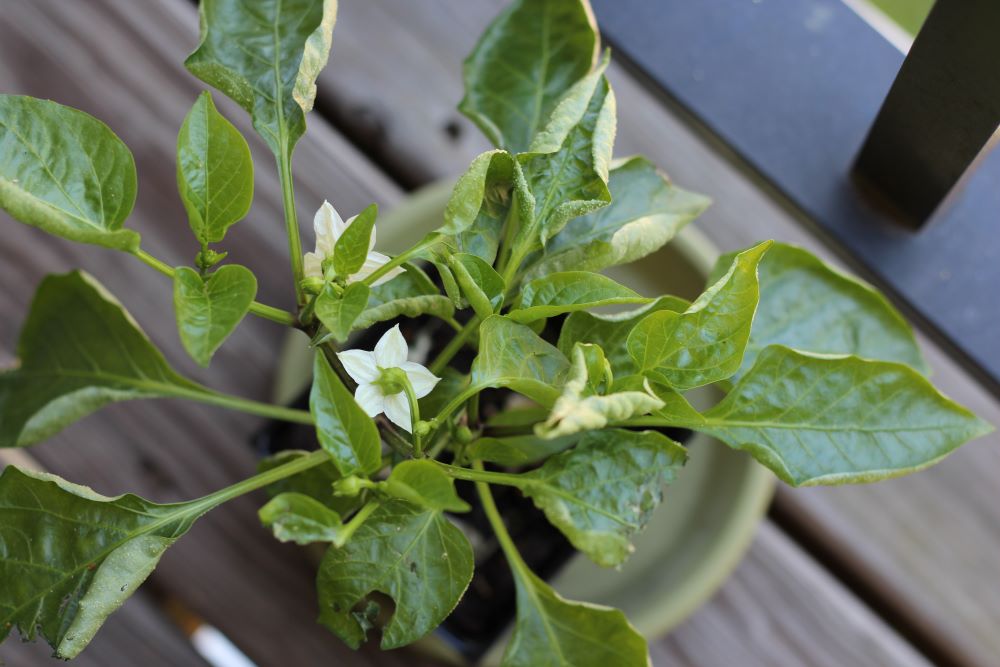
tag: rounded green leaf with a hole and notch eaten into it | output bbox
[317,500,473,649]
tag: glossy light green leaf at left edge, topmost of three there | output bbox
[0,95,139,252]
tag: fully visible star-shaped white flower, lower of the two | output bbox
[337,324,441,432]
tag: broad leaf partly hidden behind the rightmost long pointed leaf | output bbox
[715,243,929,375]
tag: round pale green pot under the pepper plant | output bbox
[276,182,774,667]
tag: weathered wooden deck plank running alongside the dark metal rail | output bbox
[320,0,1000,666]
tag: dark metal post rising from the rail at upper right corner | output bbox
[855,0,1000,229]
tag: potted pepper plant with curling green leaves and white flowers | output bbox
[0,0,990,666]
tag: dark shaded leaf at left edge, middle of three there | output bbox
[0,271,205,447]
